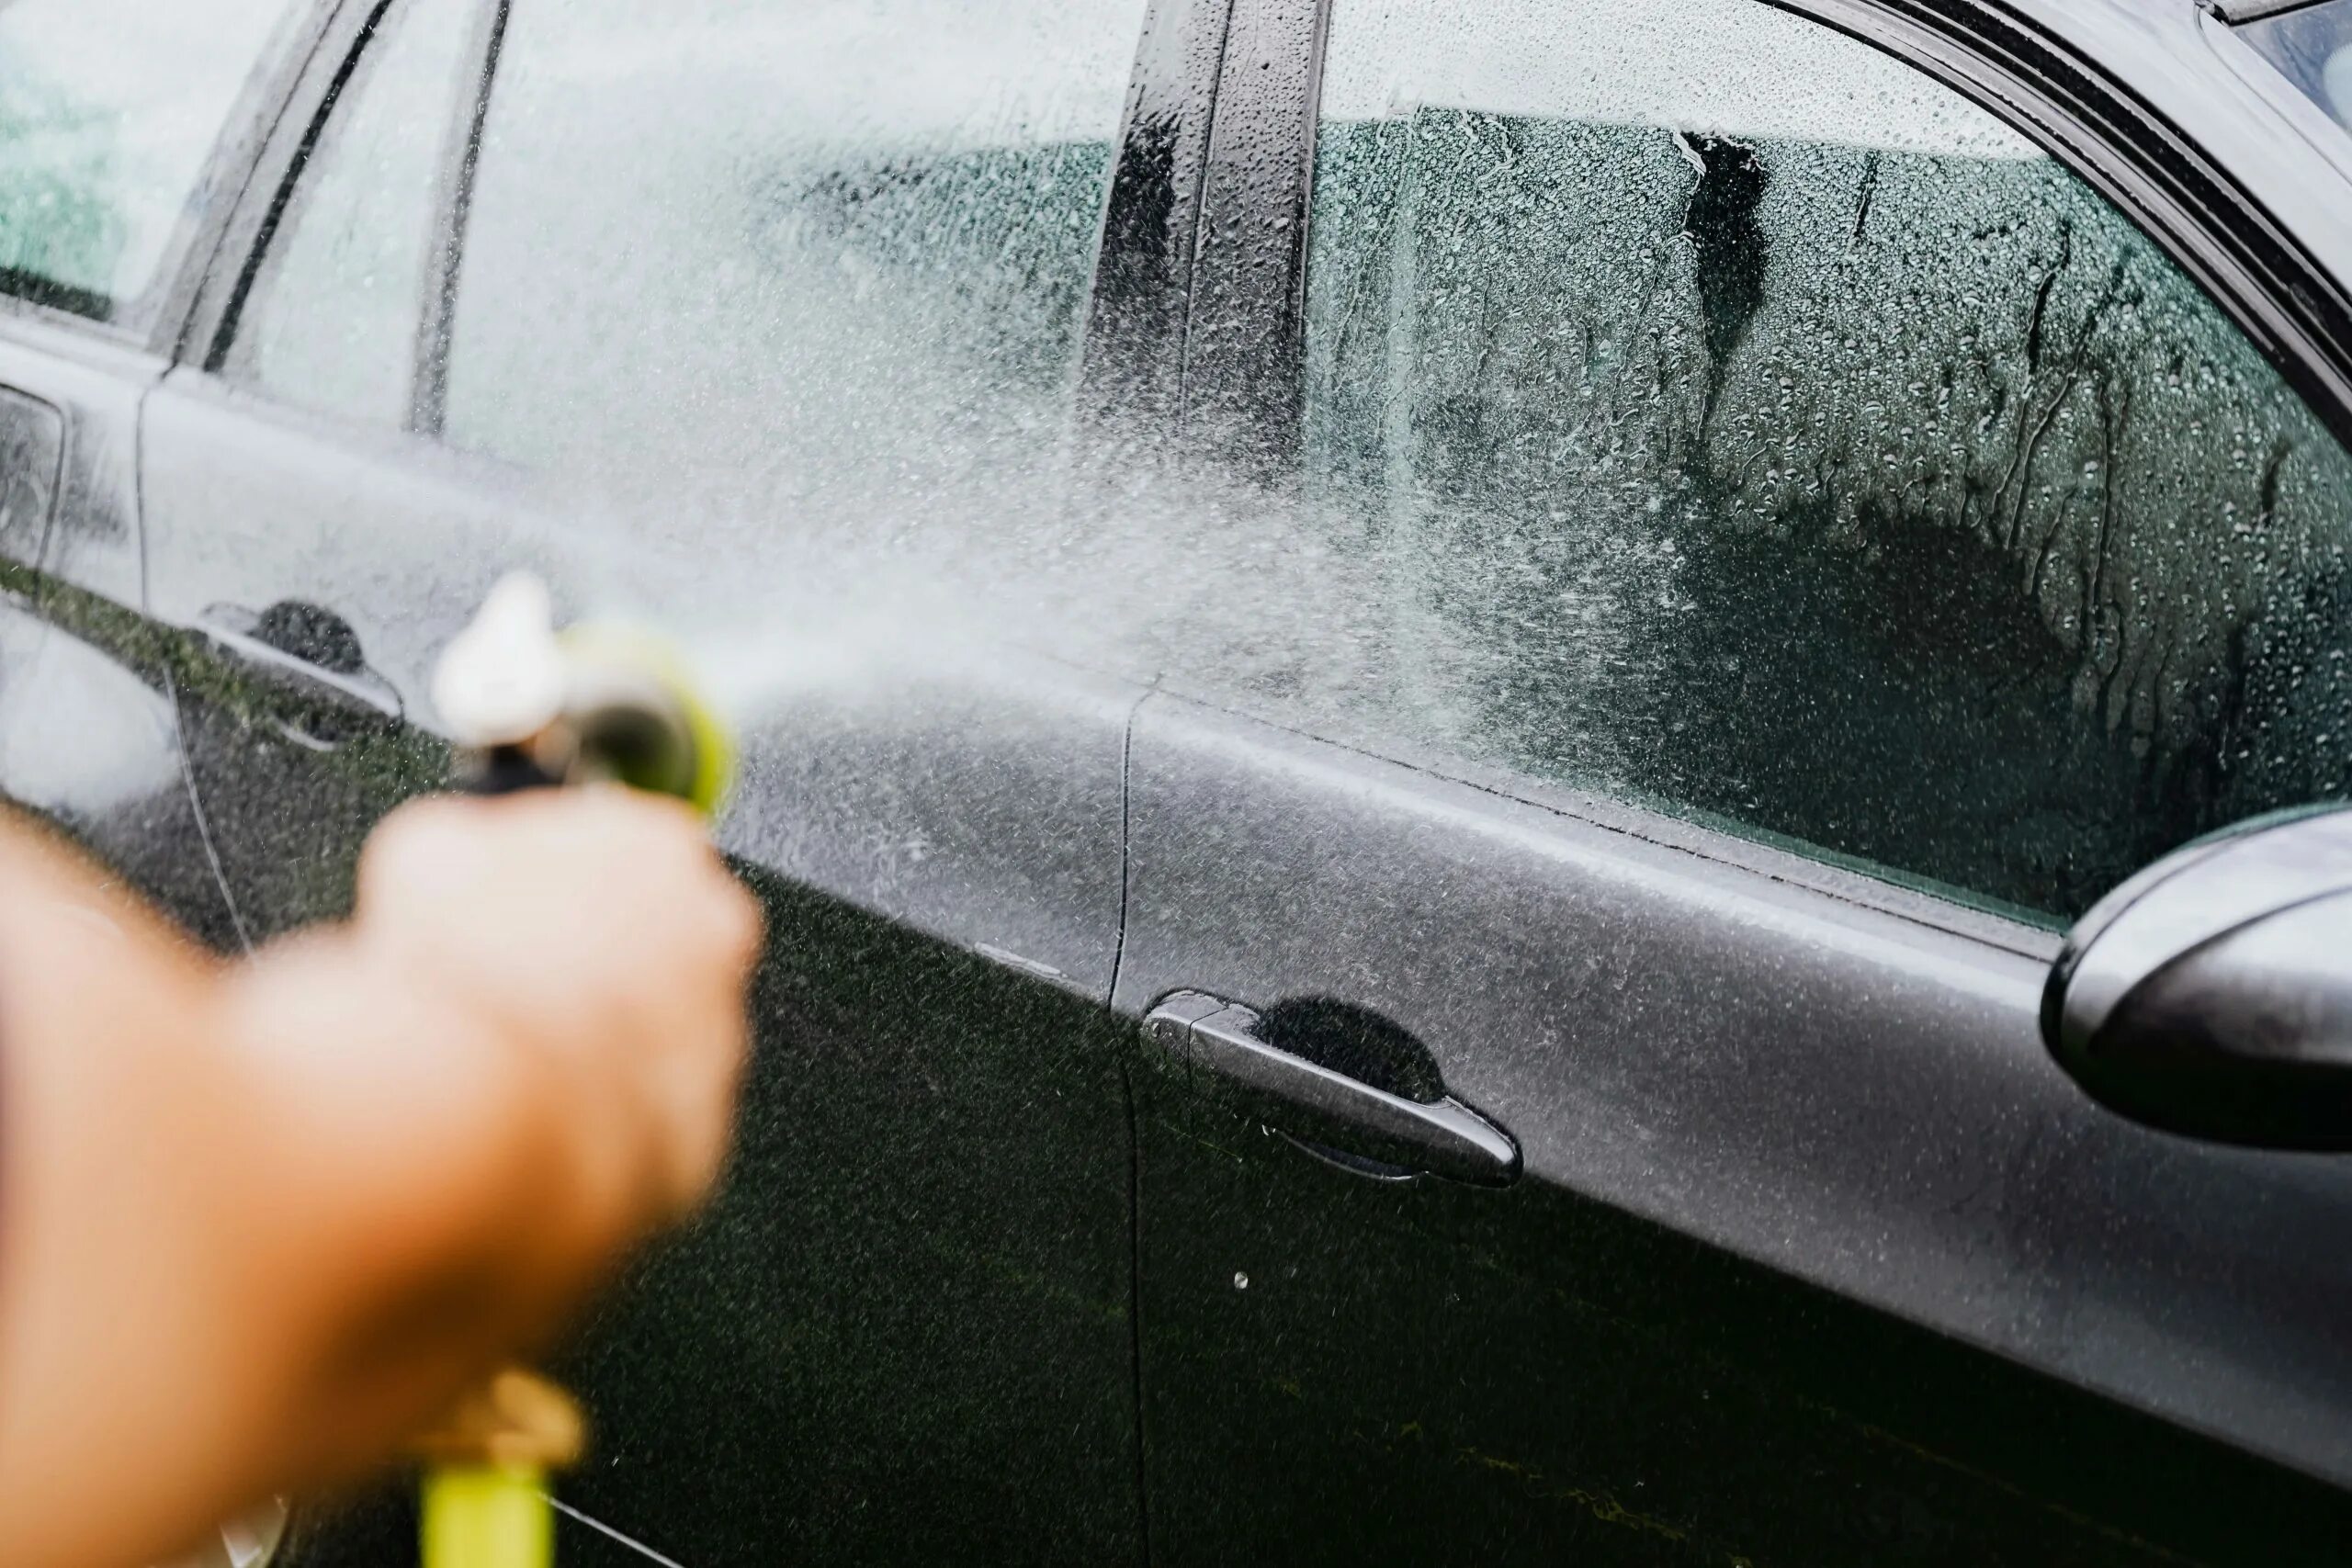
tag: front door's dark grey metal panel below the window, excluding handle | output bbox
[1117,696,2352,1561]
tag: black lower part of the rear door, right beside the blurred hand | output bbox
[291,879,1138,1568]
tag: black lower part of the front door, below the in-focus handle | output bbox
[1138,1075,2352,1568]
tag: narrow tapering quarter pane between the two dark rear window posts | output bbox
[221,0,480,430]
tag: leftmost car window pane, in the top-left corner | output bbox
[0,0,300,320]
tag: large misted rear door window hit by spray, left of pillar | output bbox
[445,0,1143,526]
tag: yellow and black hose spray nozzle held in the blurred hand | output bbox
[414,573,734,1568]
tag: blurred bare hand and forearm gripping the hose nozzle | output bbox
[0,790,760,1568]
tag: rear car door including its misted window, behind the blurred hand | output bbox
[141,0,1141,1563]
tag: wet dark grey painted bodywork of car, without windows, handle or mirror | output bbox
[0,0,2352,1568]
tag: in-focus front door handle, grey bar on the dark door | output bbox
[1143,992,1520,1187]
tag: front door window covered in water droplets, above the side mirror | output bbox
[1289,0,2352,919]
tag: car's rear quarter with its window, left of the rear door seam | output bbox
[0,0,312,945]
